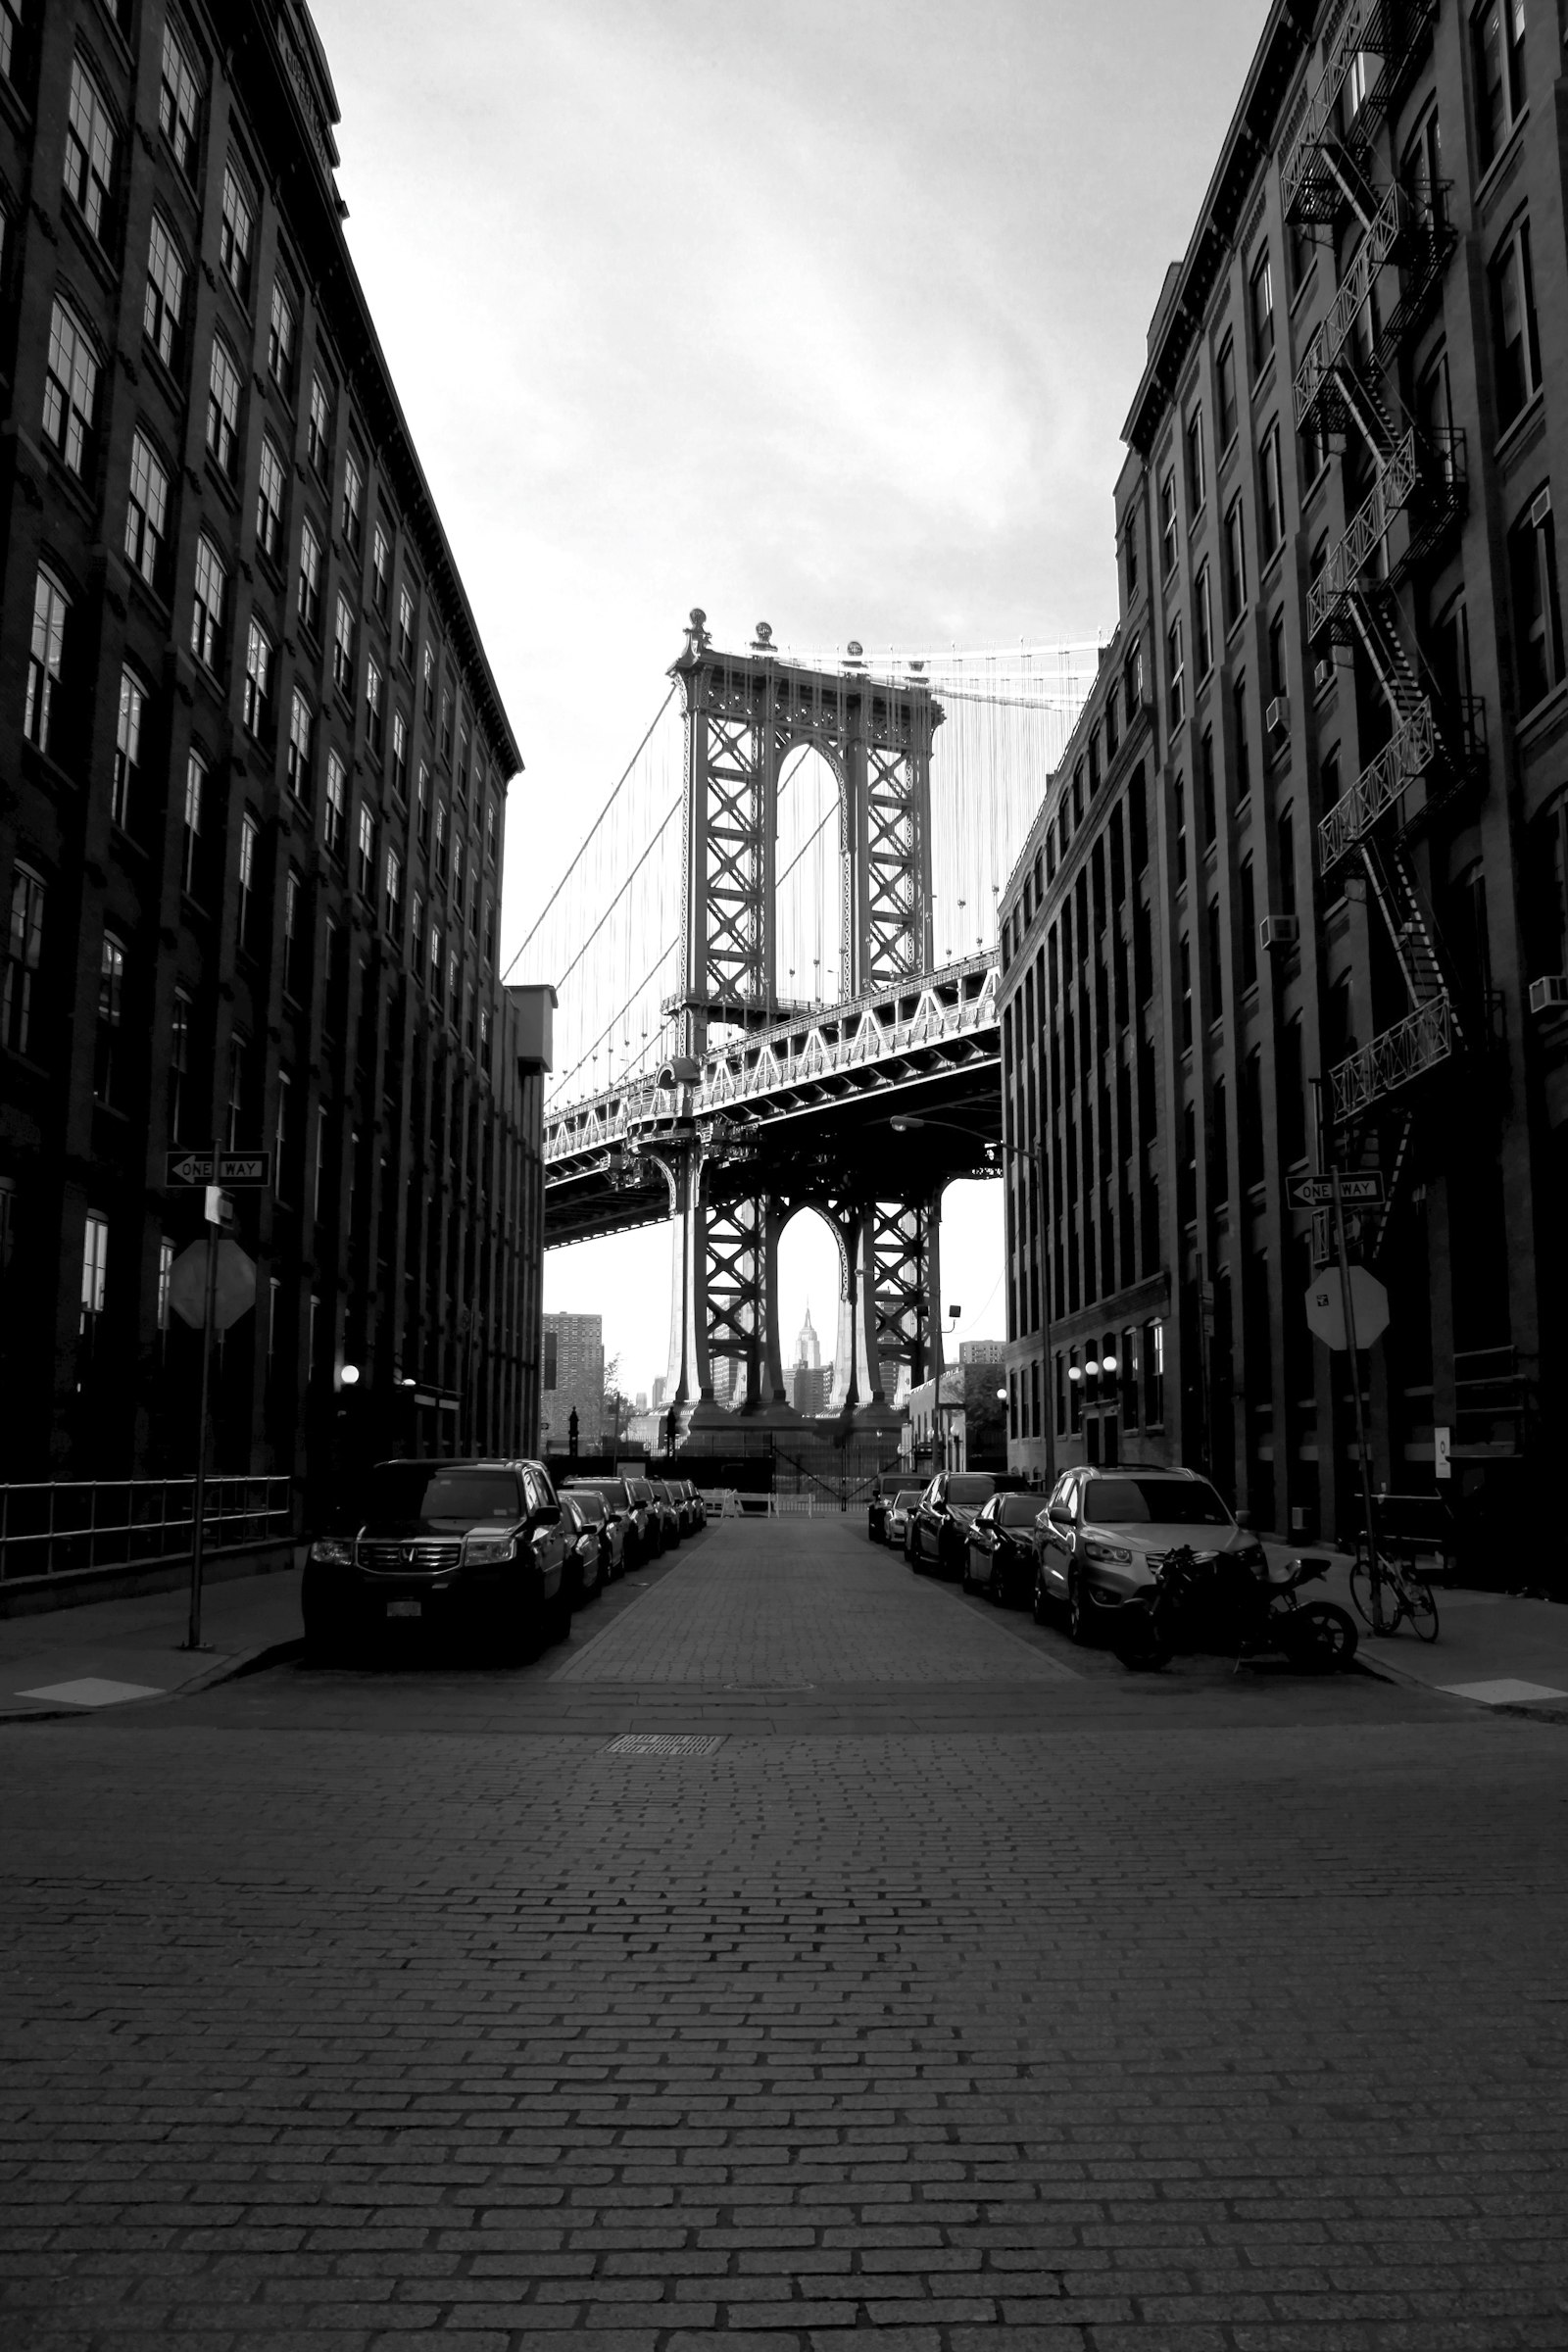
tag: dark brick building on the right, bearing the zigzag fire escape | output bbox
[1004,0,1568,1536]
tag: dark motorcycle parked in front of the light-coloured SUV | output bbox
[1109,1543,1359,1675]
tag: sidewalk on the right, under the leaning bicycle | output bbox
[1265,1543,1568,1722]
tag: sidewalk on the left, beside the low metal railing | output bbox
[0,1569,301,1722]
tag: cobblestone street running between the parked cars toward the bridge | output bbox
[0,1519,1568,2352]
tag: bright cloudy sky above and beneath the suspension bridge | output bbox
[315,0,1267,1390]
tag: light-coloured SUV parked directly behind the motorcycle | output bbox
[1034,1465,1265,1642]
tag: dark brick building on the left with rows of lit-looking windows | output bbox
[0,0,548,1477]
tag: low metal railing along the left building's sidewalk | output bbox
[0,1477,296,1586]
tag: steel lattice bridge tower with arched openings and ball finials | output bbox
[656,612,943,1430]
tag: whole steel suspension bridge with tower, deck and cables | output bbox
[511,612,1098,1445]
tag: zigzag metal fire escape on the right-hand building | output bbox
[1281,0,1486,1242]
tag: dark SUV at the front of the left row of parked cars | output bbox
[301,1460,571,1656]
